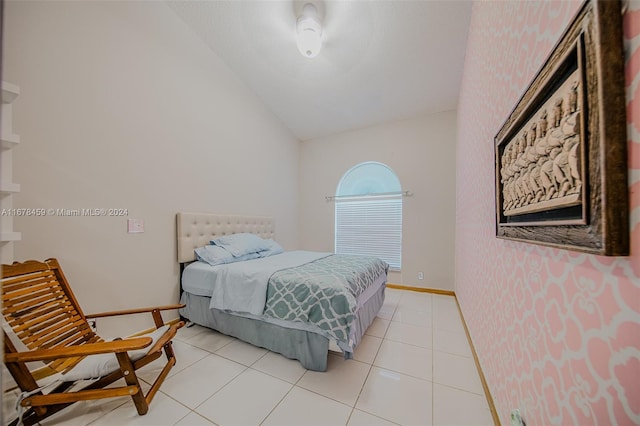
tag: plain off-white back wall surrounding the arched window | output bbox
[300,111,456,291]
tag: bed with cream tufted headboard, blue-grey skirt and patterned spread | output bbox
[176,212,388,371]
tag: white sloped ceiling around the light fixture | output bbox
[168,0,472,140]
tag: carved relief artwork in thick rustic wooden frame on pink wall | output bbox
[495,0,629,256]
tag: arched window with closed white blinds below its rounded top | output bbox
[335,162,402,270]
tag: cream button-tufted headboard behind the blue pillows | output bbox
[176,212,275,263]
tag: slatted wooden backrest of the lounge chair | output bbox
[2,259,102,371]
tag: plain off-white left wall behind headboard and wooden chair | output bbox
[3,1,299,335]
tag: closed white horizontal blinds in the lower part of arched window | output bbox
[335,194,402,270]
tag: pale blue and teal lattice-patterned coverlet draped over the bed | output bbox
[205,251,389,353]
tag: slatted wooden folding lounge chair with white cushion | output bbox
[2,259,184,425]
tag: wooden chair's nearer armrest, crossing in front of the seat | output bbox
[4,337,153,362]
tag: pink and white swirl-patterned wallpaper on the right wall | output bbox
[456,0,640,425]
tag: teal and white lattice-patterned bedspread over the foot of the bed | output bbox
[264,255,389,352]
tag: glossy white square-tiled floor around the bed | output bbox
[3,289,493,426]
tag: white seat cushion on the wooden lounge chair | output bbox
[61,325,169,382]
